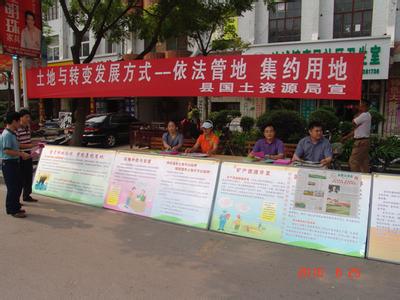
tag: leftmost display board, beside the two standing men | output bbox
[32,146,116,207]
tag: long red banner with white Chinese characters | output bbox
[27,53,364,100]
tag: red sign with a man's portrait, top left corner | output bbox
[0,0,42,57]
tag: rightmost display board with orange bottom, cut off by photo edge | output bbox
[367,174,400,263]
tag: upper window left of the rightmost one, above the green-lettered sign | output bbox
[268,0,301,43]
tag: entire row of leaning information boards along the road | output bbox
[33,146,400,262]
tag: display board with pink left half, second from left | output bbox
[104,152,219,229]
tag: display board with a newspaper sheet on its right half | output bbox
[211,162,371,257]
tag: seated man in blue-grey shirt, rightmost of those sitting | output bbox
[292,122,333,167]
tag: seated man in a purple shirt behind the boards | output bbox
[249,124,285,159]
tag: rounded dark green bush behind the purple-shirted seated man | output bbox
[257,110,306,143]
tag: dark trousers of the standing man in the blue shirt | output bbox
[2,159,22,215]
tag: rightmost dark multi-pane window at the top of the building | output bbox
[333,0,373,38]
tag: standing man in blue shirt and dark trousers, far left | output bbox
[0,112,30,218]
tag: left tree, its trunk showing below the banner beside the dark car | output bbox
[58,0,197,146]
